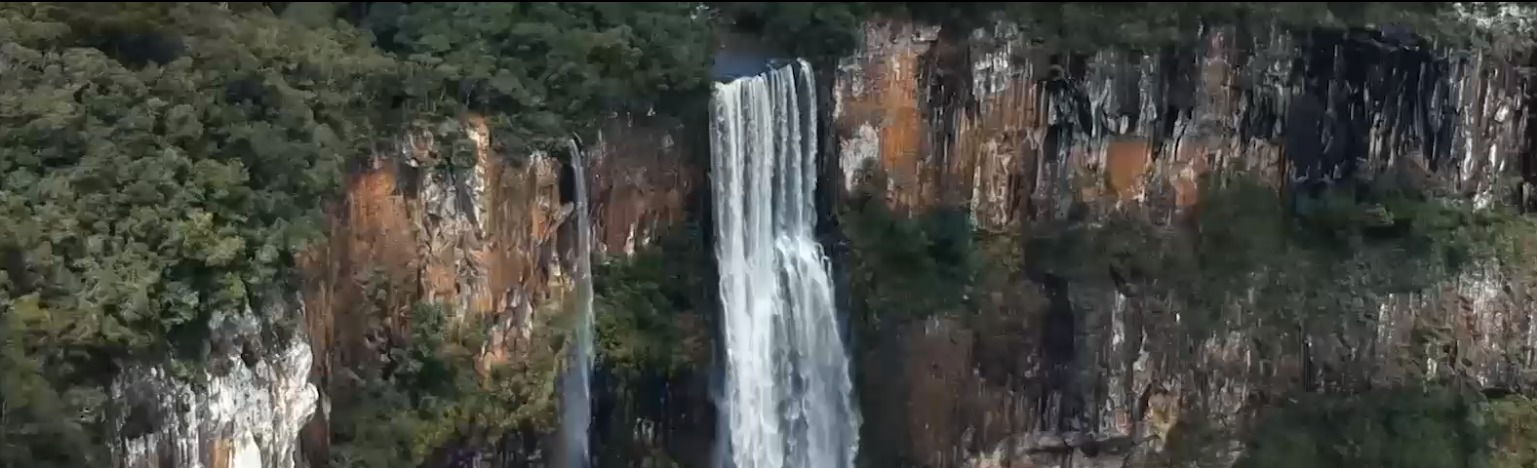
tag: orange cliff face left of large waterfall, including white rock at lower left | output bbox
[114,117,698,468]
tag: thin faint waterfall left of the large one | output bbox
[561,139,593,468]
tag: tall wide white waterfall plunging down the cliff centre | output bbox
[710,60,859,468]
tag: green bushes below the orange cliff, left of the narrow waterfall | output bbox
[332,300,559,468]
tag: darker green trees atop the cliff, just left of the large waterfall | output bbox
[364,2,713,149]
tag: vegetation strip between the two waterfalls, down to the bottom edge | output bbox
[593,222,716,466]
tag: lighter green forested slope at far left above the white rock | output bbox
[0,3,395,465]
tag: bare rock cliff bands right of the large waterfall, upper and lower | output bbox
[828,16,1537,466]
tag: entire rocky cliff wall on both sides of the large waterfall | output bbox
[99,9,1537,466]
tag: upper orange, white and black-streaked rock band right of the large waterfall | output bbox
[830,22,1528,229]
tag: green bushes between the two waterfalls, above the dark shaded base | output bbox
[593,223,715,382]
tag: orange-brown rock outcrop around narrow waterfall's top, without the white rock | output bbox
[292,117,693,462]
